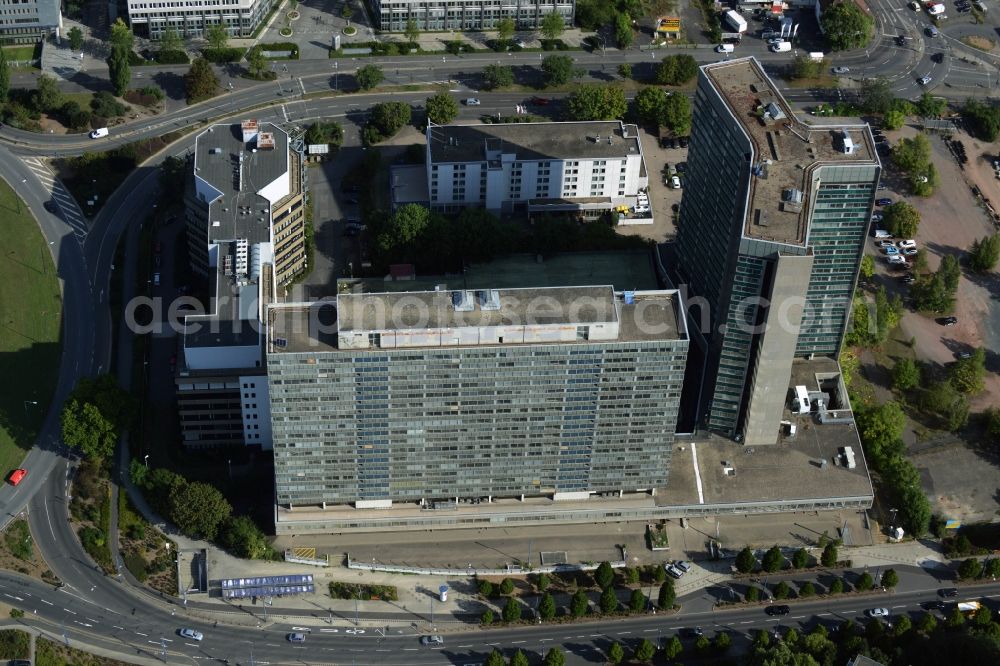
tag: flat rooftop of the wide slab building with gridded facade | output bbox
[268,286,687,354]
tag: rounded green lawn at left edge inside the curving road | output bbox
[0,180,62,477]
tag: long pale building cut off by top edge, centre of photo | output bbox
[372,0,576,32]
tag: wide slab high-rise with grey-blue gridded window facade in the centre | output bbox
[268,286,688,533]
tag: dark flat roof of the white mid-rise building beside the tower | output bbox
[427,120,641,162]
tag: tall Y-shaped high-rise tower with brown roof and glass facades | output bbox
[676,58,881,445]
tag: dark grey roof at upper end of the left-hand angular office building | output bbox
[194,122,290,245]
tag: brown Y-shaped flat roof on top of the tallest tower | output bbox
[701,57,879,245]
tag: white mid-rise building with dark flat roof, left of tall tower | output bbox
[426,120,649,217]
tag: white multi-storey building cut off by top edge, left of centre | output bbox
[128,0,277,39]
